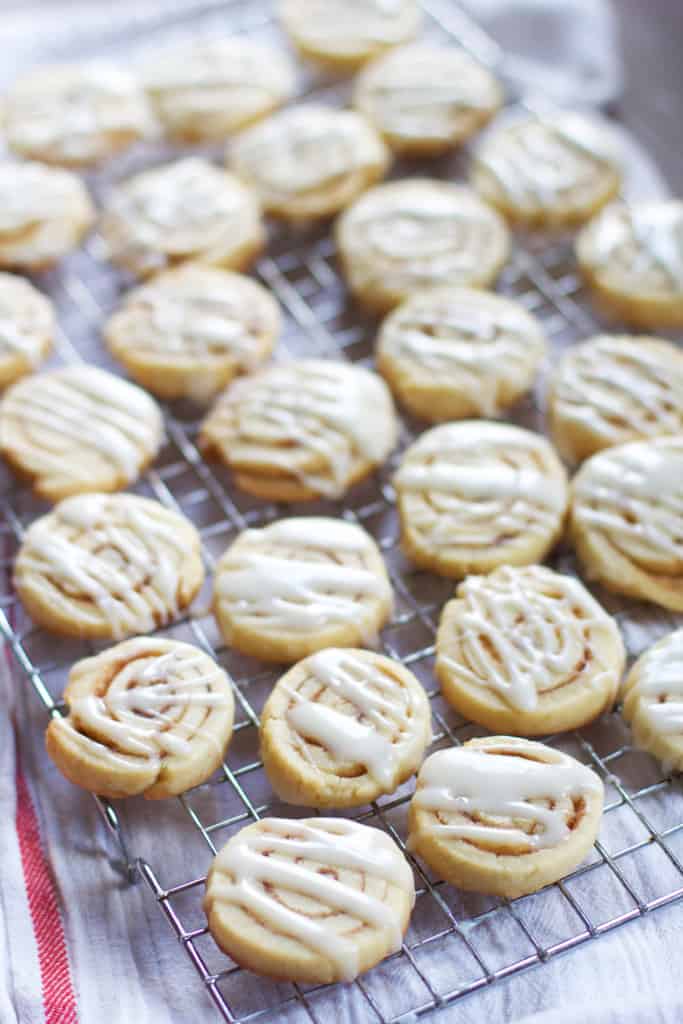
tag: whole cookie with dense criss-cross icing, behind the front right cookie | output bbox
[435,565,626,736]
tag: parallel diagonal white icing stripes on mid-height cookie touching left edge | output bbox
[2,367,163,479]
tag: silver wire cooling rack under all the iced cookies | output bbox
[0,0,683,1024]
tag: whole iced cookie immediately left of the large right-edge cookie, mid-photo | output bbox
[394,420,567,578]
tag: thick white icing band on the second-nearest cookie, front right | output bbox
[413,737,602,852]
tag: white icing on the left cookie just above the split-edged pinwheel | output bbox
[22,495,192,638]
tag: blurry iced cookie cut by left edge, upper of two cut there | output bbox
[0,162,95,272]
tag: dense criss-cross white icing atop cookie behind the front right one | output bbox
[439,566,617,711]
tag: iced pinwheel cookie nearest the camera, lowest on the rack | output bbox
[204,818,415,984]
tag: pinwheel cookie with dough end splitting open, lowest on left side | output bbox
[45,637,234,800]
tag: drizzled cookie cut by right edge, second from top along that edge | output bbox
[548,335,683,463]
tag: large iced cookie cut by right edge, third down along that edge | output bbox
[569,435,683,611]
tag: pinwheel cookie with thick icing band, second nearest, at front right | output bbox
[409,736,604,899]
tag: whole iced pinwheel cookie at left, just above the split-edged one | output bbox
[14,495,204,640]
